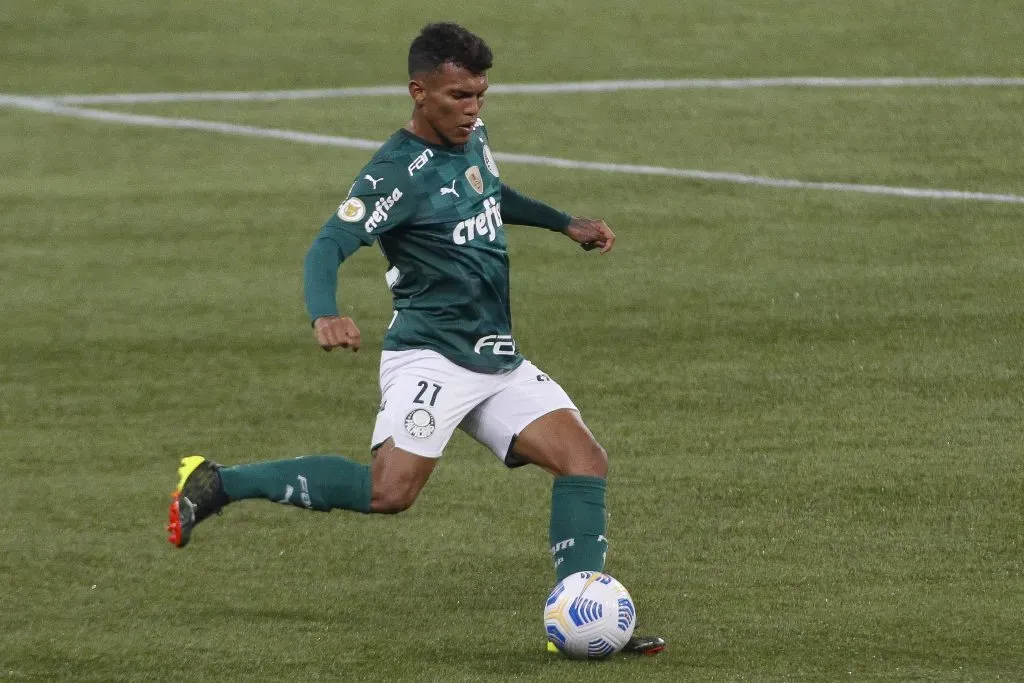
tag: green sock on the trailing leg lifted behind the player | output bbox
[220,456,370,512]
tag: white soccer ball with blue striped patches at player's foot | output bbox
[544,571,637,659]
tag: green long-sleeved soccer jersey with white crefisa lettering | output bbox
[306,121,569,373]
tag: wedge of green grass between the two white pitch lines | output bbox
[117,88,1024,194]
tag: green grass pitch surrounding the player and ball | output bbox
[0,0,1024,682]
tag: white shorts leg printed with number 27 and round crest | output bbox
[371,349,490,458]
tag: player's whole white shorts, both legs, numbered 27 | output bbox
[371,349,579,467]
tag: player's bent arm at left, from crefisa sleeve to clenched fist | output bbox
[303,161,415,351]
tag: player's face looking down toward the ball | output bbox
[410,63,487,144]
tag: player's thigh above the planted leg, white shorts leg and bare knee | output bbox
[460,360,607,476]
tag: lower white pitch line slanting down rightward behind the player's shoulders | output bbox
[0,95,1024,204]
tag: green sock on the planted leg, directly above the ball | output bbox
[549,476,608,583]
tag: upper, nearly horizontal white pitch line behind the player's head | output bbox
[28,76,1024,104]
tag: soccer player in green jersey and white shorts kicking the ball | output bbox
[168,24,665,653]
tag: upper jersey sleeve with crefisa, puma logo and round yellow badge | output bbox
[333,160,416,245]
